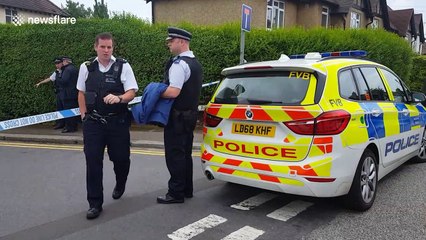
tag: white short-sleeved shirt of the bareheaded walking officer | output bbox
[77,56,139,92]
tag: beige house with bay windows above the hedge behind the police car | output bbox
[146,0,390,29]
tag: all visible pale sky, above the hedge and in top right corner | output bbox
[50,0,426,24]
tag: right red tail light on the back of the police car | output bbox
[284,110,351,135]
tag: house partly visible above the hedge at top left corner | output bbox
[0,0,69,23]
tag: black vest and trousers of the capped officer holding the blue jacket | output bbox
[164,56,203,199]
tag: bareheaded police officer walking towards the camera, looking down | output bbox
[77,33,138,219]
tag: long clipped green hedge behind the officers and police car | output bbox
[0,18,413,120]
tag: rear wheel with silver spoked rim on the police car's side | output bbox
[345,149,378,211]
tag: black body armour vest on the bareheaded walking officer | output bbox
[86,58,127,115]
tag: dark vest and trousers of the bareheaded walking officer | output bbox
[83,58,130,209]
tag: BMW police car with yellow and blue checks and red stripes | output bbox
[201,50,426,211]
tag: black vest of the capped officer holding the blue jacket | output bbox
[163,56,203,111]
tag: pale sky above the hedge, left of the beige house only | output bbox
[50,0,151,21]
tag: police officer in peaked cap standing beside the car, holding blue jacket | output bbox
[157,27,203,204]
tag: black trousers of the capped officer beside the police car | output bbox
[164,112,196,199]
